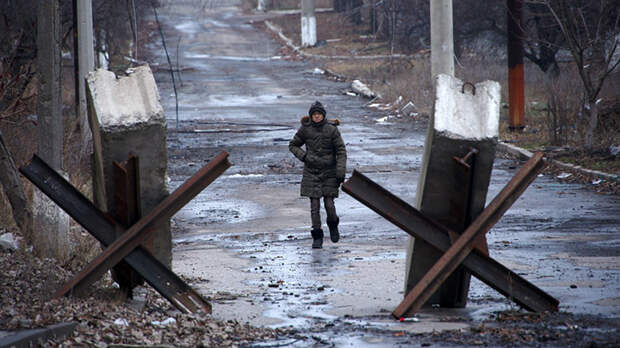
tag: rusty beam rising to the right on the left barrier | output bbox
[55,152,230,297]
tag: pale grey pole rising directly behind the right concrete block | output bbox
[430,0,454,78]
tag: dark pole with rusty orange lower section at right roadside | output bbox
[507,0,525,131]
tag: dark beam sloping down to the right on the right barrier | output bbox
[342,154,559,312]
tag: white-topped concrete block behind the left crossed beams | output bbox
[87,66,172,267]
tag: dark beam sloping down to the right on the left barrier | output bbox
[19,155,228,313]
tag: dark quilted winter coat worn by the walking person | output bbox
[288,116,347,198]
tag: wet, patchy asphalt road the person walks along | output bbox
[150,1,620,347]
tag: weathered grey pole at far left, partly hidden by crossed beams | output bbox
[33,0,69,261]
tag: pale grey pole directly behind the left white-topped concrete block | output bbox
[73,0,95,152]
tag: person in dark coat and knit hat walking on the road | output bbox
[288,101,347,248]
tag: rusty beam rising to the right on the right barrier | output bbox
[392,152,545,318]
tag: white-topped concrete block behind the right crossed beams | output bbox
[405,74,501,307]
